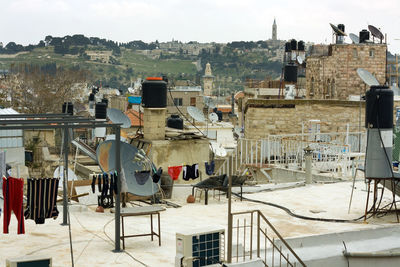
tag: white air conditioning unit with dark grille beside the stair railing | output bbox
[175,228,225,267]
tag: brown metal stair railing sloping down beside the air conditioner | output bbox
[228,210,306,267]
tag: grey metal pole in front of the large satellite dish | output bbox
[113,125,121,252]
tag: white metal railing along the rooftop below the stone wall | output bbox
[217,132,366,179]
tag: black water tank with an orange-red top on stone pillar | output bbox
[142,77,167,108]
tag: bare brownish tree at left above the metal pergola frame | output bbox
[3,65,87,113]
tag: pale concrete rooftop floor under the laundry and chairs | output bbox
[0,181,397,267]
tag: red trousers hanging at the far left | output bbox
[3,177,25,234]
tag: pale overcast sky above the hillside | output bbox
[0,0,400,53]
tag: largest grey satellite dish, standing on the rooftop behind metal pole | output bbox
[96,140,161,196]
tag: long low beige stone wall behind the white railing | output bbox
[244,99,400,139]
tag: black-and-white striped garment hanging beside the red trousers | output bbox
[24,178,60,224]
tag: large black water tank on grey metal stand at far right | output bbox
[365,86,393,129]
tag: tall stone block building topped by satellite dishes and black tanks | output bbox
[306,43,386,100]
